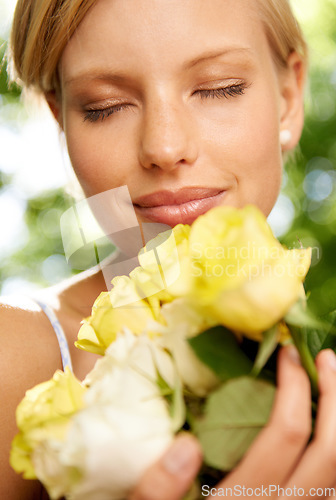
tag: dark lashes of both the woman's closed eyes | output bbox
[84,83,246,123]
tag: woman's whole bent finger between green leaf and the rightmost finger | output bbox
[224,346,311,488]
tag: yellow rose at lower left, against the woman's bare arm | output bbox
[10,368,86,479]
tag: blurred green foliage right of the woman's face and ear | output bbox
[281,0,336,314]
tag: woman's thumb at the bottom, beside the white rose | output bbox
[129,434,202,500]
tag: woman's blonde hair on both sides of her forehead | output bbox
[10,0,307,93]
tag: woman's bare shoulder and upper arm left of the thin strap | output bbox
[0,297,61,500]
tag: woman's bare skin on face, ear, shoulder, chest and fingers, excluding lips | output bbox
[0,0,336,500]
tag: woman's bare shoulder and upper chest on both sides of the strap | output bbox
[0,273,103,500]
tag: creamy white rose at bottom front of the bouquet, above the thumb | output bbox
[60,331,174,500]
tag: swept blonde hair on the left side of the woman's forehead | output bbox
[9,0,97,93]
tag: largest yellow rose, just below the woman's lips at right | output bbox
[189,206,311,340]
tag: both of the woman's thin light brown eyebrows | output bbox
[64,47,252,85]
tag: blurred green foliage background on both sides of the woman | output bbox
[0,0,336,313]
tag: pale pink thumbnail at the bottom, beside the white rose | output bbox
[162,436,195,475]
